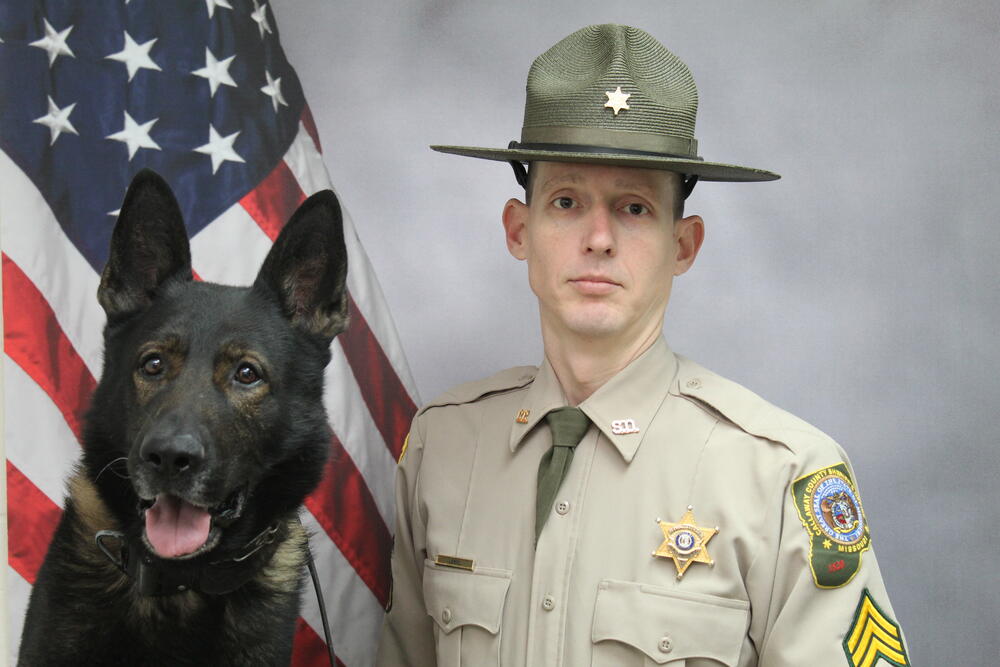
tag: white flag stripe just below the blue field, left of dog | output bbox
[0,151,104,378]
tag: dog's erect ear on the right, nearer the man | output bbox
[254,190,348,340]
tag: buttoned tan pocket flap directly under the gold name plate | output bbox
[424,560,511,634]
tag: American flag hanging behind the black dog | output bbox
[0,0,415,665]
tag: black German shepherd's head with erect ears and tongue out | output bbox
[84,171,348,560]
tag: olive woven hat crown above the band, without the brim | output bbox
[522,24,698,157]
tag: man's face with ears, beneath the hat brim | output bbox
[503,162,704,345]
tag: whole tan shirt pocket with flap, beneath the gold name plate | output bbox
[424,560,511,667]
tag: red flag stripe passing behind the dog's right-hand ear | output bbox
[240,162,417,459]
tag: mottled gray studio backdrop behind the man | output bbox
[272,0,1000,665]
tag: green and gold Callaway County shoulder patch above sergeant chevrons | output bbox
[792,463,871,588]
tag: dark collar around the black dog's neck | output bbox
[94,521,288,597]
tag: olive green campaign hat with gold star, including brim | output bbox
[431,24,780,186]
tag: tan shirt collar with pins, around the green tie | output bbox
[510,337,677,463]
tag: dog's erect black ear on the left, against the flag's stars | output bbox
[97,169,191,319]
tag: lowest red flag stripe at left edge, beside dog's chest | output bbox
[4,464,62,585]
